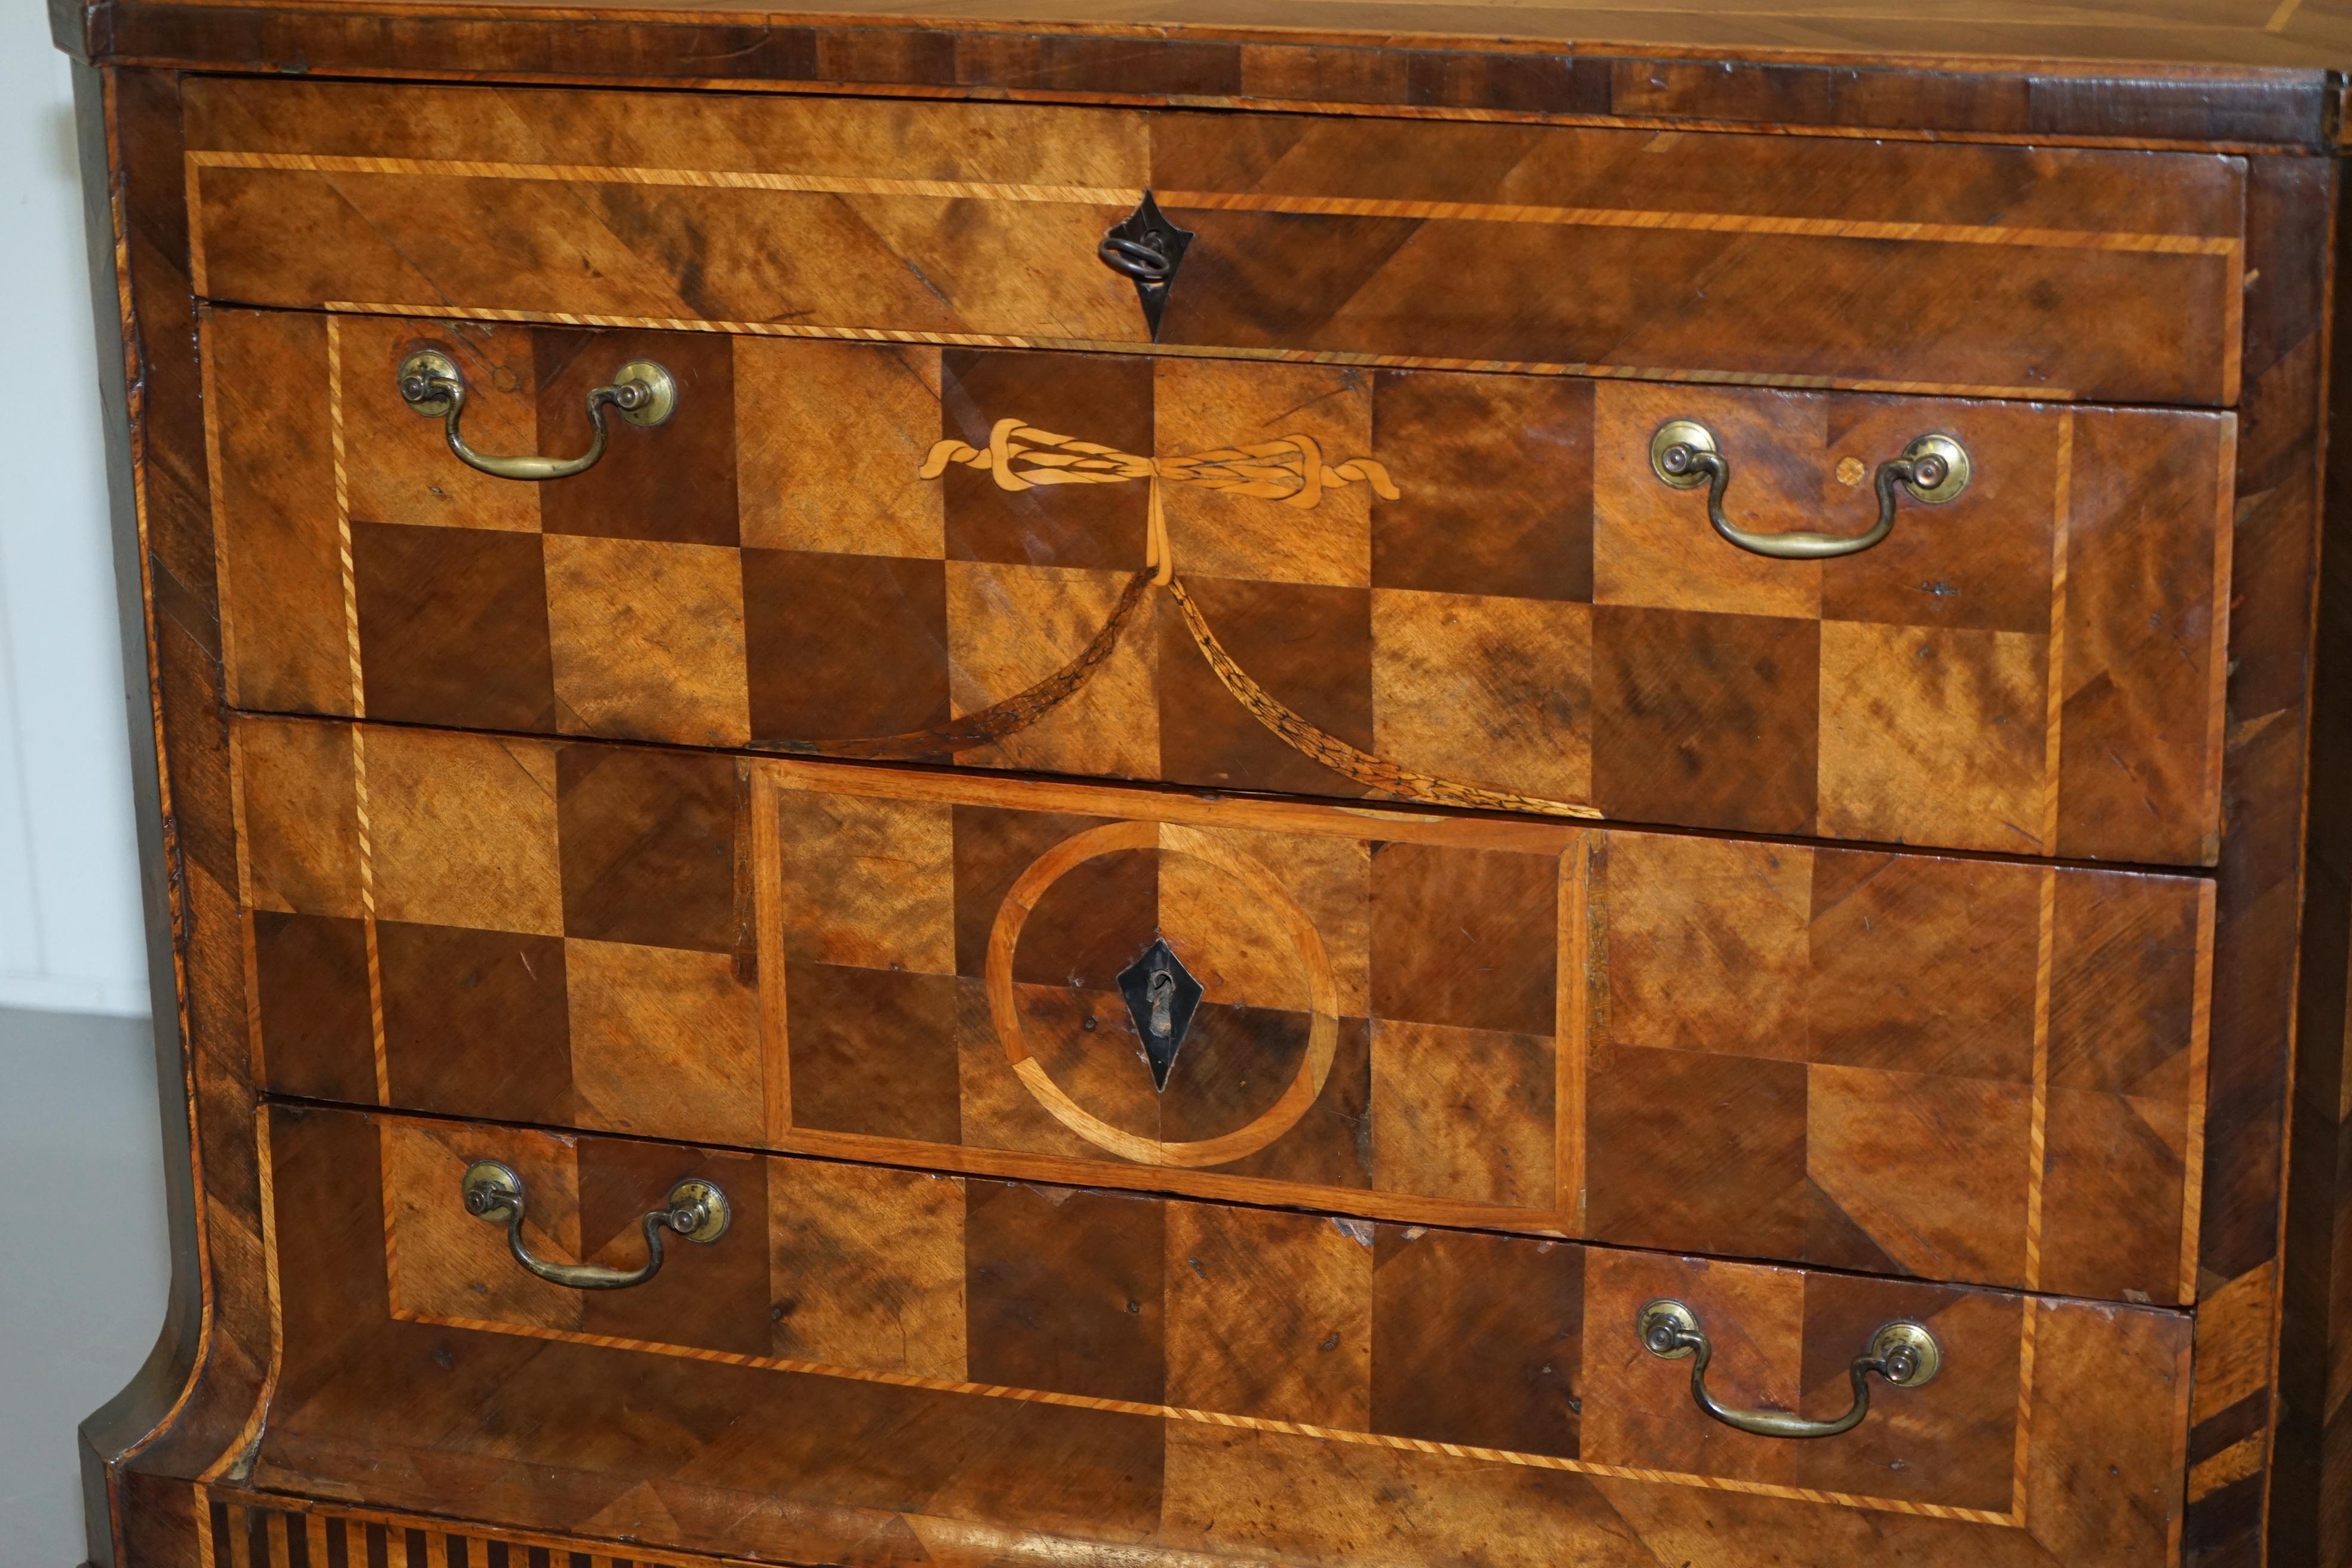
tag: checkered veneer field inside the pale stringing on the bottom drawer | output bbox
[379,1117,2032,1518]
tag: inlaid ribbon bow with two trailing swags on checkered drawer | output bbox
[752,418,1599,816]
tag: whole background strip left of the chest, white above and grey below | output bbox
[0,12,167,1568]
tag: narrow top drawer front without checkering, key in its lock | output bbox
[186,80,2246,407]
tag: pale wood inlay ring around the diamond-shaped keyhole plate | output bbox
[988,823,1339,1168]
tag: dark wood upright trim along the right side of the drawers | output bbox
[2180,158,2340,1568]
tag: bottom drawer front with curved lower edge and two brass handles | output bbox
[254,1107,2189,1563]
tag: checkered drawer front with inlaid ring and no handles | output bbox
[235,719,2213,1302]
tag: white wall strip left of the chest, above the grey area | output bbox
[0,46,148,1020]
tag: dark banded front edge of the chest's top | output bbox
[50,0,2342,153]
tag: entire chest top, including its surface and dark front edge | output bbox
[52,0,2352,151]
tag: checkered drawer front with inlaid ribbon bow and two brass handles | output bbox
[207,313,2237,865]
